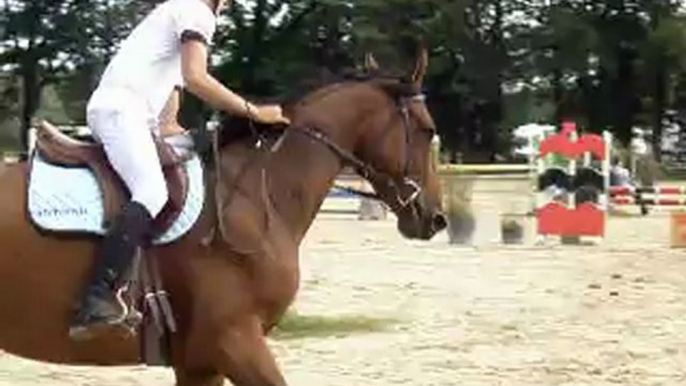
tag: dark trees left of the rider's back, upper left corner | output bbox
[0,0,150,149]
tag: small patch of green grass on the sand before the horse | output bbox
[272,311,398,339]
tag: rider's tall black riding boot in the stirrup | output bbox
[69,202,153,340]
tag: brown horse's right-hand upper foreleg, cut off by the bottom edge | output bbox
[217,318,286,386]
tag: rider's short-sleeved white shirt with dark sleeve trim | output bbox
[88,0,217,120]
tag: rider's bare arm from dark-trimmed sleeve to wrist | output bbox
[181,39,257,116]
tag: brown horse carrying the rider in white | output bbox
[0,49,446,386]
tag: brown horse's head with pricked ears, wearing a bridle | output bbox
[355,50,447,239]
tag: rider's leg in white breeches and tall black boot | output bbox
[70,107,168,339]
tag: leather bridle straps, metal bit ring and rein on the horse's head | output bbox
[288,94,426,211]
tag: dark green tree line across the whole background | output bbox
[0,0,686,162]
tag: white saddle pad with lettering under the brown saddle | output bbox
[28,153,205,245]
